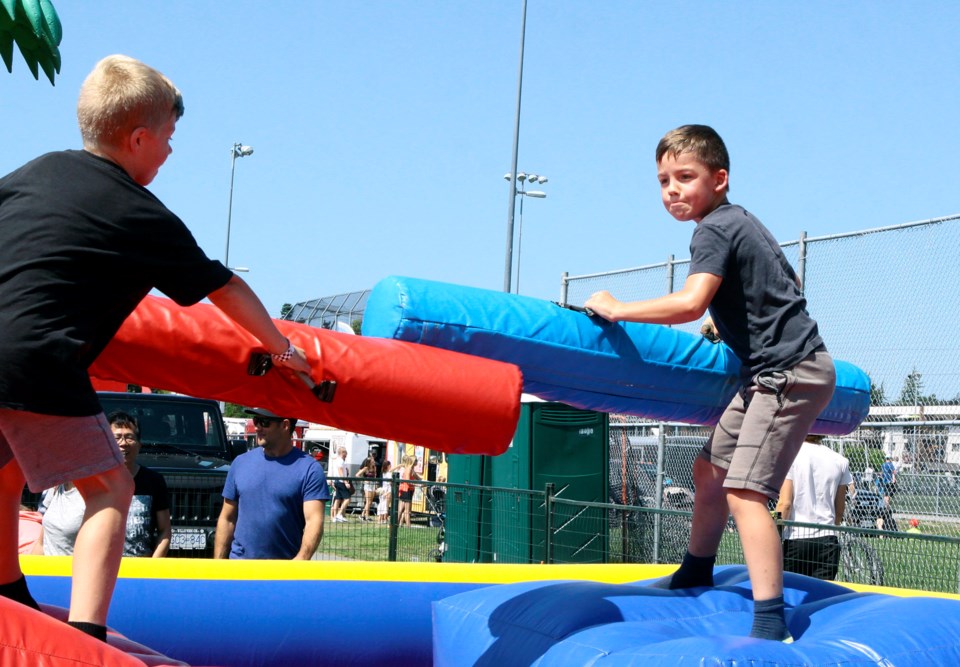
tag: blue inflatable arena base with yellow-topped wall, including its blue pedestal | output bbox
[22,556,960,667]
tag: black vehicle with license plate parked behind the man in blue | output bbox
[99,392,246,557]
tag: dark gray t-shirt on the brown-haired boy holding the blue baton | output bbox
[690,204,823,377]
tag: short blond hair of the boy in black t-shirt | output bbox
[77,55,183,147]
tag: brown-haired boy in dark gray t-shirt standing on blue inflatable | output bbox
[585,125,836,640]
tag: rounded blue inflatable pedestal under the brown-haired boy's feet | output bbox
[433,565,960,667]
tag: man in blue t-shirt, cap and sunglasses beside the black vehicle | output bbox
[213,408,330,560]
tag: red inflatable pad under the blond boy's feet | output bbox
[0,598,187,667]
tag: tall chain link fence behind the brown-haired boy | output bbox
[561,215,960,537]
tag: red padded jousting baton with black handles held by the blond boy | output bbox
[90,296,523,455]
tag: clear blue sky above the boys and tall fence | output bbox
[0,0,960,315]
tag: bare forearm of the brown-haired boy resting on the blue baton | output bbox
[584,273,723,324]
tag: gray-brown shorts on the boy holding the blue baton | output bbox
[700,348,836,498]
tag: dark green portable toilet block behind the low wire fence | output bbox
[445,397,609,563]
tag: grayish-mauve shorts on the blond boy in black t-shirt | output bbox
[0,409,123,493]
